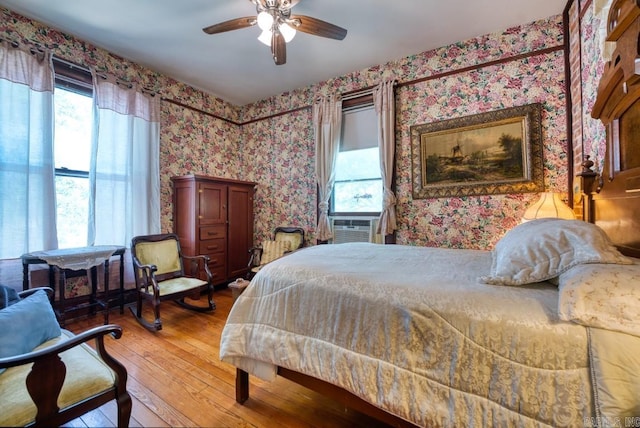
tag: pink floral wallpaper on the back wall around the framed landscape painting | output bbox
[242,17,569,249]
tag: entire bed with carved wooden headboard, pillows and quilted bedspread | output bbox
[220,1,640,426]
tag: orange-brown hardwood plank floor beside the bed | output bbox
[61,289,386,428]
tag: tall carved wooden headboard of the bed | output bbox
[580,0,640,257]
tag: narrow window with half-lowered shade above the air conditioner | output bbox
[331,104,383,215]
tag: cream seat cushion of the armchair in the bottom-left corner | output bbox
[0,330,116,426]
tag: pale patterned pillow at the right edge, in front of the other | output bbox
[558,261,640,336]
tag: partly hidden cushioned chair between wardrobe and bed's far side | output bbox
[247,226,304,279]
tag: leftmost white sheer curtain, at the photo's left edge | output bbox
[0,40,58,259]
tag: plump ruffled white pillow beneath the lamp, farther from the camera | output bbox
[480,218,632,285]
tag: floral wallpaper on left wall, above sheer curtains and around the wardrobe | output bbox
[0,8,243,241]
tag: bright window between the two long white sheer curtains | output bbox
[53,62,93,248]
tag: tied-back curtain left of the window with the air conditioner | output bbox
[312,94,342,241]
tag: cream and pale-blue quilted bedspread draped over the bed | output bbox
[220,244,594,426]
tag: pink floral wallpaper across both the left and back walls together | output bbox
[0,8,592,254]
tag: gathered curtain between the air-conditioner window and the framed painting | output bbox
[373,81,398,236]
